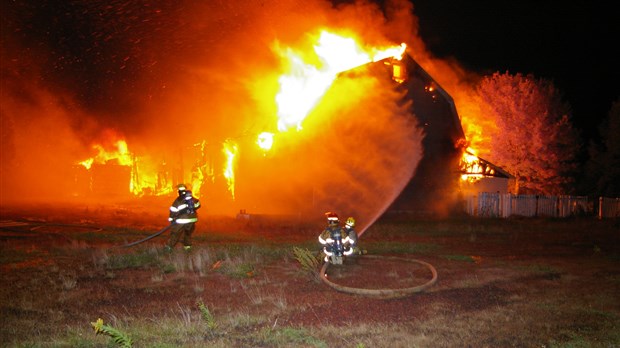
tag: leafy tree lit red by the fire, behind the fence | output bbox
[477,72,580,194]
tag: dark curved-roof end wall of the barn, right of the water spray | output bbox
[370,55,465,214]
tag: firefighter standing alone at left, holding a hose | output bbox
[164,184,200,252]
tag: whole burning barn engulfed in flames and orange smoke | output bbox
[1,1,512,228]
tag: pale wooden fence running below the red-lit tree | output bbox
[465,192,620,219]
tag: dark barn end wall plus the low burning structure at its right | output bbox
[332,50,514,215]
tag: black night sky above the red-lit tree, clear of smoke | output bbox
[413,0,620,143]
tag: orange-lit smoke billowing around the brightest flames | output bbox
[1,0,432,226]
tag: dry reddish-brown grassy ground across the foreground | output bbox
[0,216,620,348]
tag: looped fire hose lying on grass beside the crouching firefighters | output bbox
[320,255,437,299]
